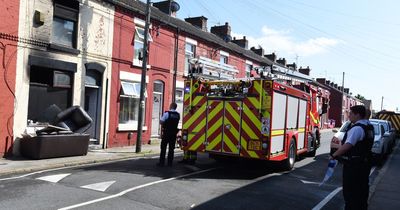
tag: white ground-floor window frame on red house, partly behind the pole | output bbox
[118,71,149,131]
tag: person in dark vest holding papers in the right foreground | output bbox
[331,105,374,210]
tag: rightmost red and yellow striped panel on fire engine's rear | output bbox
[240,80,264,158]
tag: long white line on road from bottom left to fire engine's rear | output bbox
[59,168,217,210]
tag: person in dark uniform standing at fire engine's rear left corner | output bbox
[157,103,180,166]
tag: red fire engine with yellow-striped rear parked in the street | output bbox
[182,63,321,170]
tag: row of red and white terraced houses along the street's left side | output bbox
[0,0,329,158]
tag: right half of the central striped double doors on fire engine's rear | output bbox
[222,101,242,154]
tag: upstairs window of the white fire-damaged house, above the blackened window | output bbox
[52,0,79,48]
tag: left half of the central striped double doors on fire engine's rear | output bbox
[206,100,224,152]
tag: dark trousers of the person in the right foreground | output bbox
[343,161,371,210]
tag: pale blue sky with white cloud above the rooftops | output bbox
[155,0,400,111]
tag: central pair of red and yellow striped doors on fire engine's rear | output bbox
[206,100,242,154]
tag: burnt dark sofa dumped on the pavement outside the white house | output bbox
[20,105,92,159]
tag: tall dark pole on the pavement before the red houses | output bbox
[136,0,150,153]
